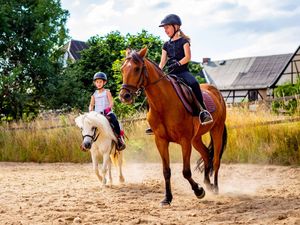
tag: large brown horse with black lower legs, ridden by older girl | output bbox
[120,48,227,205]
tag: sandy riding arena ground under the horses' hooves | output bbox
[0,163,300,225]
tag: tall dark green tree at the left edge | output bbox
[0,0,69,120]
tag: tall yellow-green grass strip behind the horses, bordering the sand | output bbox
[0,107,300,165]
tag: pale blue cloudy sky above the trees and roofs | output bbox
[61,0,300,62]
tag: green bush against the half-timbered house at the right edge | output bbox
[272,78,300,114]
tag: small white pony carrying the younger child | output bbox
[75,111,124,186]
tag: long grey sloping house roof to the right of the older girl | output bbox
[203,50,294,90]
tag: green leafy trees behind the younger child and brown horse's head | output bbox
[61,30,163,117]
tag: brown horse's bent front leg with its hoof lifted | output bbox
[181,142,205,198]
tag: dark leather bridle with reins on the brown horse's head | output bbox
[121,51,166,99]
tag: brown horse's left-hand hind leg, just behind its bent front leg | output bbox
[192,137,212,190]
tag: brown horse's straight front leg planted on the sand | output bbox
[155,137,173,206]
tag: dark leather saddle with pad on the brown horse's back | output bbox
[167,74,216,116]
